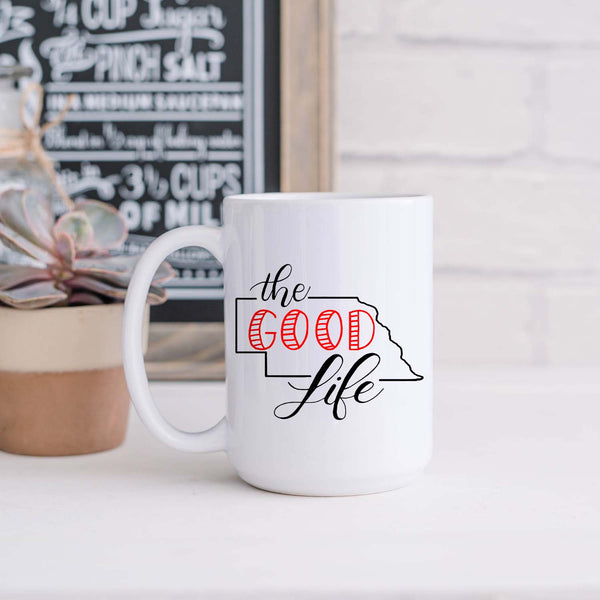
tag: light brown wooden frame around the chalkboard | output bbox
[146,0,335,380]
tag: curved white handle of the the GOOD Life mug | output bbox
[123,225,227,452]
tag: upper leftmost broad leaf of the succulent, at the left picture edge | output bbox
[0,188,54,252]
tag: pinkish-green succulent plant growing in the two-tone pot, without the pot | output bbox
[0,188,174,309]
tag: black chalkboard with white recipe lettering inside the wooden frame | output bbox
[0,0,280,321]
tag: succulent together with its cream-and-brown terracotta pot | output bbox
[0,188,173,455]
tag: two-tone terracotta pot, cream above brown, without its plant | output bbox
[0,304,148,456]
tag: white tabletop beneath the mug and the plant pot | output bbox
[0,369,600,600]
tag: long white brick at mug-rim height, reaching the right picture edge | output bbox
[338,158,600,277]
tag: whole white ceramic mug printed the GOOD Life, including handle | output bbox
[123,193,433,496]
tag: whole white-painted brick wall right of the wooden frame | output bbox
[338,0,600,365]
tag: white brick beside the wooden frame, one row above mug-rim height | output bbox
[339,48,533,158]
